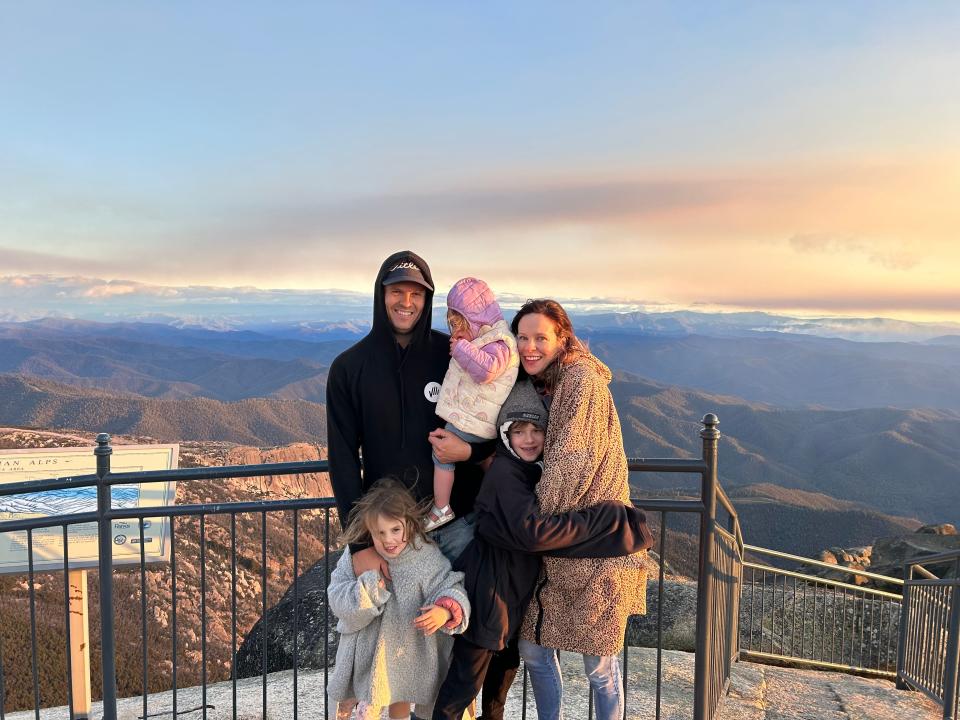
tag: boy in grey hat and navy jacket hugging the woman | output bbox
[433,380,653,720]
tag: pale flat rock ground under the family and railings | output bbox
[6,649,941,720]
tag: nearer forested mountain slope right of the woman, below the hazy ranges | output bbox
[611,373,960,522]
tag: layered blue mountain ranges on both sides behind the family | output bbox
[0,313,960,522]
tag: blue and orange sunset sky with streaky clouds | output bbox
[0,0,960,321]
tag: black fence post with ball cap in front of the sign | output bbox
[93,433,117,720]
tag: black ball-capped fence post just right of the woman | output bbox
[693,413,720,720]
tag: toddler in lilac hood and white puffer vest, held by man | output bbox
[426,277,520,532]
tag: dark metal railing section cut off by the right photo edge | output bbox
[897,550,960,720]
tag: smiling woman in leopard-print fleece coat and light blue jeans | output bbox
[511,300,647,720]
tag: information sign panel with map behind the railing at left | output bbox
[0,445,180,573]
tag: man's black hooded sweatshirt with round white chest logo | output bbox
[327,250,493,544]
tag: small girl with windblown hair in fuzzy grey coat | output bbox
[327,478,470,720]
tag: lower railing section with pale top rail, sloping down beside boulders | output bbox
[740,545,903,678]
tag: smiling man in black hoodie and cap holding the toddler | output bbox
[327,250,495,575]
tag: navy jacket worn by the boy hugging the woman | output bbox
[454,443,653,650]
